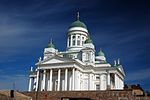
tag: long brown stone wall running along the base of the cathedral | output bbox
[23,91,150,100]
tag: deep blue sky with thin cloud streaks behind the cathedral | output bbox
[0,0,150,91]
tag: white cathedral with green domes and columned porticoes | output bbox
[28,14,125,91]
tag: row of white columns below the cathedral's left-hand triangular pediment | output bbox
[34,68,78,91]
